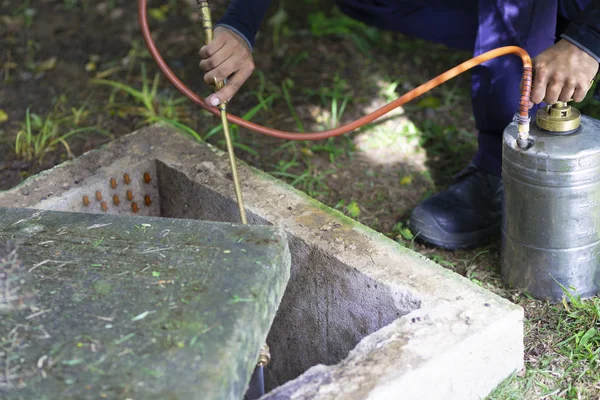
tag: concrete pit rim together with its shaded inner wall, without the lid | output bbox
[0,127,524,400]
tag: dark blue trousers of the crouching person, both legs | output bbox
[339,0,591,175]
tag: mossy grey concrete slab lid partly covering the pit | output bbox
[0,208,290,400]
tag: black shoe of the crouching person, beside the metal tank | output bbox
[409,164,502,250]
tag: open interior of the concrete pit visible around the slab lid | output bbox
[15,160,420,390]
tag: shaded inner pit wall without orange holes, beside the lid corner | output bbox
[157,161,420,390]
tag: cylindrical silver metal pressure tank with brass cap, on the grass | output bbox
[501,103,600,301]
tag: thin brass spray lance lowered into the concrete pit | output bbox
[198,0,271,398]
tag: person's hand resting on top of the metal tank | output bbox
[531,39,598,104]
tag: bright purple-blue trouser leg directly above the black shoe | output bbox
[472,0,557,175]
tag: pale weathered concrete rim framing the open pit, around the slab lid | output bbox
[0,126,524,400]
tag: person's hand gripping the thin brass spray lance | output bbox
[200,26,254,106]
